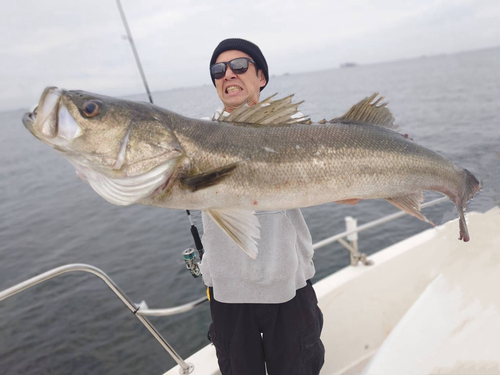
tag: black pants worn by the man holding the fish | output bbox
[209,280,325,375]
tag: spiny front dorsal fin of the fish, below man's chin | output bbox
[217,94,312,127]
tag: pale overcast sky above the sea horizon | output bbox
[0,0,500,110]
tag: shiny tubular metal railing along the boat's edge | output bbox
[0,197,448,374]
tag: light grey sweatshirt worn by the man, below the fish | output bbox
[201,209,315,303]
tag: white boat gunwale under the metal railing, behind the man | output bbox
[164,207,500,375]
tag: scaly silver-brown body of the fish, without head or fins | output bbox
[154,119,460,210]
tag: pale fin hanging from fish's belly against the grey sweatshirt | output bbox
[205,208,260,259]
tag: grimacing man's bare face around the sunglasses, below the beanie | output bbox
[215,50,266,112]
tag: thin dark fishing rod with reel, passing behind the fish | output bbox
[116,0,205,277]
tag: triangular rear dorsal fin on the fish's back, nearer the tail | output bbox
[330,92,398,129]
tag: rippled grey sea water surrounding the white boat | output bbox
[0,48,500,375]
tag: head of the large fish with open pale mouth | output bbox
[23,87,184,205]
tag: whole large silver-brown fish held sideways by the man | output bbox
[23,87,479,258]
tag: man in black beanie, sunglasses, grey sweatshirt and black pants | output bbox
[202,39,324,375]
